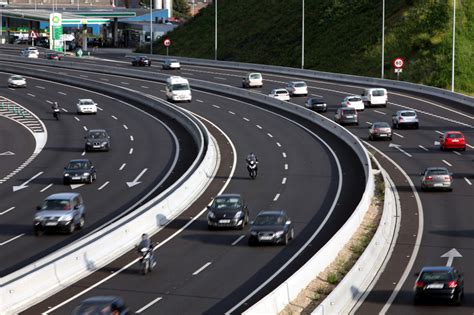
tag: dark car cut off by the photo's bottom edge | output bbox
[72,296,131,315]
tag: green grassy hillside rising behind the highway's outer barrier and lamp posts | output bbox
[144,0,474,94]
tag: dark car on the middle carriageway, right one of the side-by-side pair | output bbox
[249,210,295,246]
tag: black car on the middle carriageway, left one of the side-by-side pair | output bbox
[207,194,249,230]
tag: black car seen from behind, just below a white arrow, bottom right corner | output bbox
[414,266,464,305]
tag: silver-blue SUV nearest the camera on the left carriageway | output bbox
[33,192,85,236]
